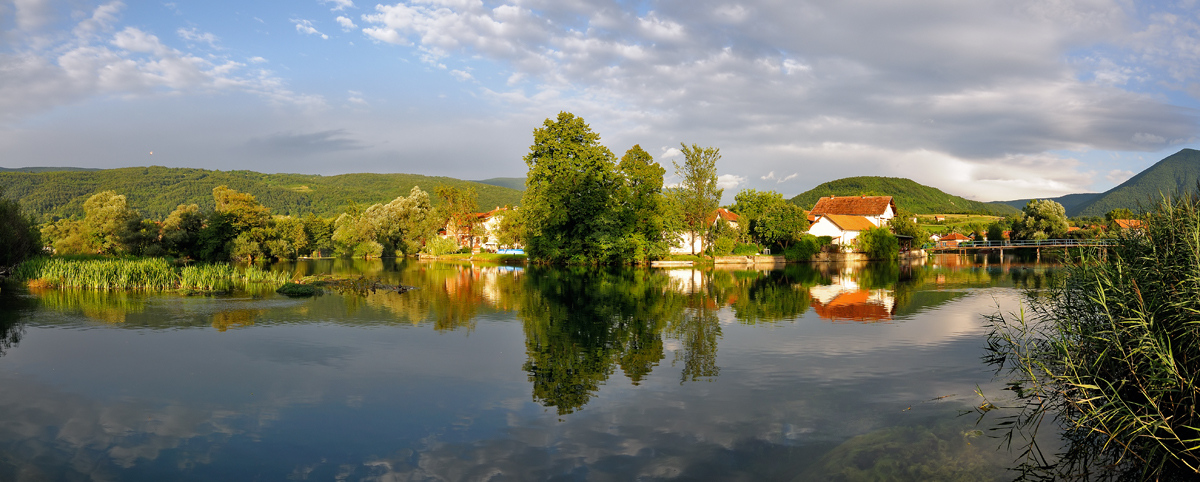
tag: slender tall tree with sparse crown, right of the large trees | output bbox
[671,144,725,254]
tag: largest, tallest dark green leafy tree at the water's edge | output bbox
[521,112,622,263]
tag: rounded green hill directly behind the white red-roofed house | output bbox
[791,176,1018,216]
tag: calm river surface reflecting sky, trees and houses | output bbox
[0,257,1051,481]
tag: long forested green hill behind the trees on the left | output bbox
[0,167,521,219]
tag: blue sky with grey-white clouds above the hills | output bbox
[0,0,1200,203]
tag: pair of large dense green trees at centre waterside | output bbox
[517,112,667,264]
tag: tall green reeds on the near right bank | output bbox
[989,190,1200,480]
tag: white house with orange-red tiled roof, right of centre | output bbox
[809,195,896,246]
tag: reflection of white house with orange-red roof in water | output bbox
[809,276,896,323]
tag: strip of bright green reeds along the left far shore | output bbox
[13,257,292,293]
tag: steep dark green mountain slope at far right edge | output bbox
[1067,149,1200,216]
